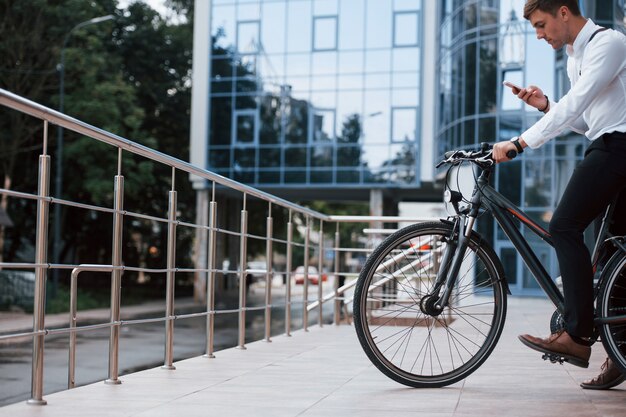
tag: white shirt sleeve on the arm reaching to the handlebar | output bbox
[522,36,626,149]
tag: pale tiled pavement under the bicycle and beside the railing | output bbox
[0,298,626,417]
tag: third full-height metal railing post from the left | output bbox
[161,181,177,370]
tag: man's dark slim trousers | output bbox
[549,132,626,337]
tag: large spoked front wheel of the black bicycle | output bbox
[354,222,506,388]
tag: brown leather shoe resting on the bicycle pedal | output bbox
[518,330,591,368]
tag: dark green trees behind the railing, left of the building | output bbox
[0,0,195,286]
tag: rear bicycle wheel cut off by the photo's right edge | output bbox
[597,251,626,373]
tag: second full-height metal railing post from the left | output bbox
[104,163,124,385]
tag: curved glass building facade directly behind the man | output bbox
[437,0,626,294]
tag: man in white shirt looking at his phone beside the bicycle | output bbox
[493,0,626,389]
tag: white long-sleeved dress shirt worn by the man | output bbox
[522,19,626,148]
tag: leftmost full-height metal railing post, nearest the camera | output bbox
[28,146,50,405]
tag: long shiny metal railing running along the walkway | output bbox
[0,89,438,405]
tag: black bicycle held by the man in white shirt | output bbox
[354,144,626,388]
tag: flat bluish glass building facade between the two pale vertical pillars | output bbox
[208,0,430,188]
